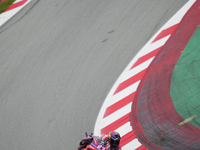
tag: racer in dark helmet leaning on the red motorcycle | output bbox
[77,131,121,150]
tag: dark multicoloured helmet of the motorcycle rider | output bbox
[108,131,121,148]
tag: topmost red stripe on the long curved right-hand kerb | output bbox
[152,23,179,43]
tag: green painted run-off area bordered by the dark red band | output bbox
[170,27,200,128]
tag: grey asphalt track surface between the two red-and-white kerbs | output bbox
[0,0,187,150]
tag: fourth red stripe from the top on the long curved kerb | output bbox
[103,92,135,118]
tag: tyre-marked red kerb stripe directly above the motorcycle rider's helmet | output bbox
[101,113,130,134]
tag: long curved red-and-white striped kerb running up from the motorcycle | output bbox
[94,0,196,150]
